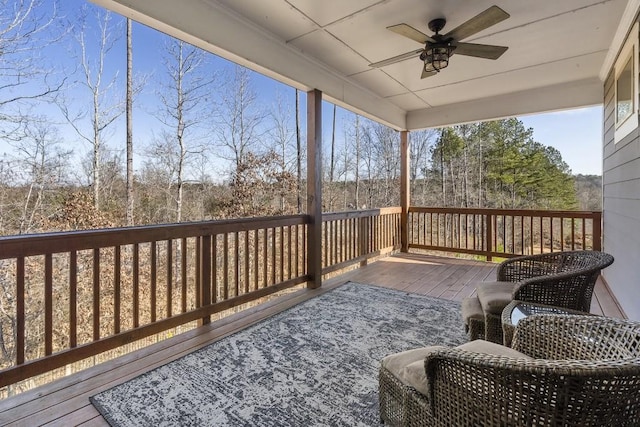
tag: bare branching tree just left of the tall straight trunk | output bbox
[59,8,124,209]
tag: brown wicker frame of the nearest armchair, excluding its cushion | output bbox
[380,315,640,426]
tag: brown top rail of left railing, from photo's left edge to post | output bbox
[0,215,310,259]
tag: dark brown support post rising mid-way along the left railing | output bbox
[307,89,322,289]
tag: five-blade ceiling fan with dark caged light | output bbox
[369,6,510,79]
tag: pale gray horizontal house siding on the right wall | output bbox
[603,51,640,320]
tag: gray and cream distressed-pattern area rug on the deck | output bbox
[91,283,466,427]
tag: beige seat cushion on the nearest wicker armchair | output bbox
[382,340,531,395]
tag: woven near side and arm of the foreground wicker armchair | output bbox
[425,349,640,425]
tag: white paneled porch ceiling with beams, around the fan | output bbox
[94,0,637,129]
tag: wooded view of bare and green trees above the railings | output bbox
[0,0,598,241]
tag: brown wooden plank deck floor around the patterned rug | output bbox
[0,254,622,426]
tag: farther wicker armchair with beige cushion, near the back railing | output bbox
[463,251,613,343]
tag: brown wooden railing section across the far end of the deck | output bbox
[408,207,601,260]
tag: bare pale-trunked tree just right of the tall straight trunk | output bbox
[153,39,215,222]
